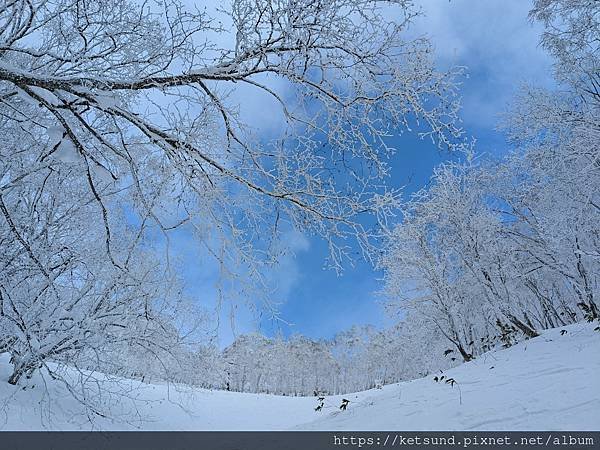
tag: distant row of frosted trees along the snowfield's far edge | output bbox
[78,324,452,396]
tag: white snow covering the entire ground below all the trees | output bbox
[0,324,600,430]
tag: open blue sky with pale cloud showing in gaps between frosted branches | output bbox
[176,0,552,345]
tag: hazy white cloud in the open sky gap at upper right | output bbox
[412,0,552,127]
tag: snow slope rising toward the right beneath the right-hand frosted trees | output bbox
[300,324,600,431]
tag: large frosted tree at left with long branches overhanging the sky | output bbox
[0,0,462,400]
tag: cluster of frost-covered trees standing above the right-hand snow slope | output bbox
[382,0,600,366]
